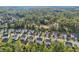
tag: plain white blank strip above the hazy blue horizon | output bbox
[0,0,79,6]
